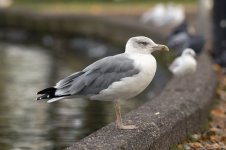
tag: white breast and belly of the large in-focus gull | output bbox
[90,54,156,100]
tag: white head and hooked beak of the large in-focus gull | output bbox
[125,36,169,54]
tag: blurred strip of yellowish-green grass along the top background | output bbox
[12,0,196,14]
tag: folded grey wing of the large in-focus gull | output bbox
[56,53,139,96]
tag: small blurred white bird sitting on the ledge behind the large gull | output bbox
[169,48,197,76]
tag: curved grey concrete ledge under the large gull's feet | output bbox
[67,53,217,150]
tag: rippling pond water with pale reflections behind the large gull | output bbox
[0,43,170,150]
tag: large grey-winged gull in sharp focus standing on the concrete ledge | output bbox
[37,36,169,129]
